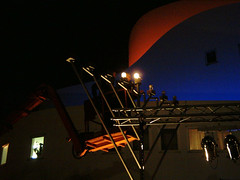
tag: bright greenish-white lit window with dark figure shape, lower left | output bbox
[30,137,44,159]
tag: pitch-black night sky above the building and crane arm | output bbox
[0,0,176,117]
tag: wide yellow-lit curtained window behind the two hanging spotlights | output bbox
[188,129,240,150]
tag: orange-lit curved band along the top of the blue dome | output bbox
[129,0,240,66]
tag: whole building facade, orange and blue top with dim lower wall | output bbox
[0,1,240,180]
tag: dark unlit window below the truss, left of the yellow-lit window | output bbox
[161,129,178,150]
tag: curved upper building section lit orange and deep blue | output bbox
[128,1,240,100]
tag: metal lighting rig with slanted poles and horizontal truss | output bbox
[67,58,240,180]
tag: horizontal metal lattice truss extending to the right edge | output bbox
[112,102,240,126]
